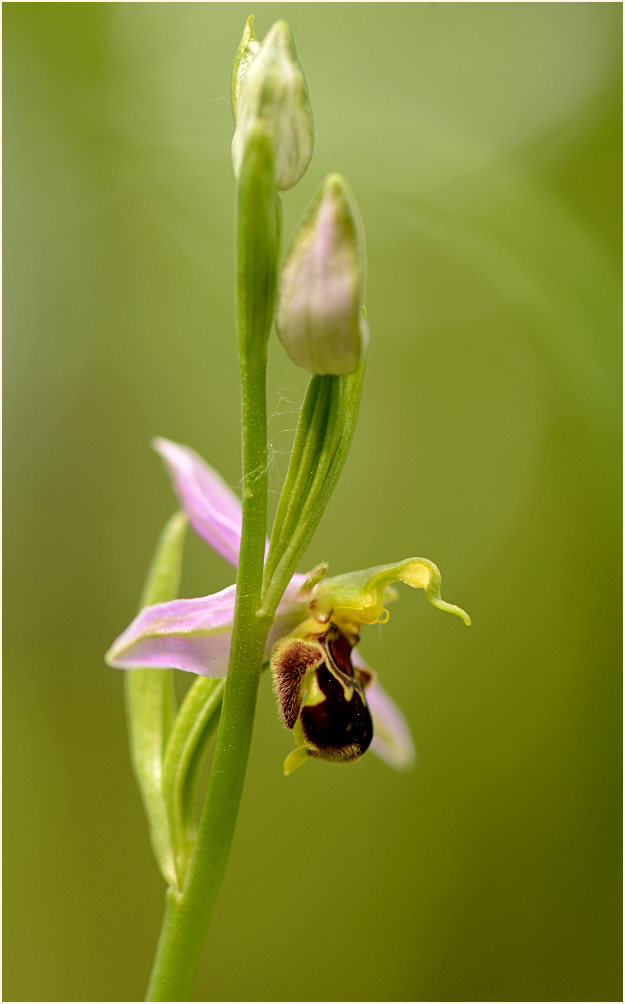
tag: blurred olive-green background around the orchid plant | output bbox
[3,3,622,1001]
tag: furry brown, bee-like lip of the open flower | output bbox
[271,623,373,772]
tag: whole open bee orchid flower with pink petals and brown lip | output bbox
[106,439,471,773]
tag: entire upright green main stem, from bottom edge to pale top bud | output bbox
[146,127,280,1001]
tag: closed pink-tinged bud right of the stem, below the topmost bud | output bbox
[276,174,369,375]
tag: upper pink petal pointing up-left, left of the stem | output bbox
[152,439,245,565]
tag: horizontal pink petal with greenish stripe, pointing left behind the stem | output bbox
[106,583,305,677]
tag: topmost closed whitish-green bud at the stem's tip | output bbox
[232,19,313,189]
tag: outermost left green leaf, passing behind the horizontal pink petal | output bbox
[124,512,188,886]
